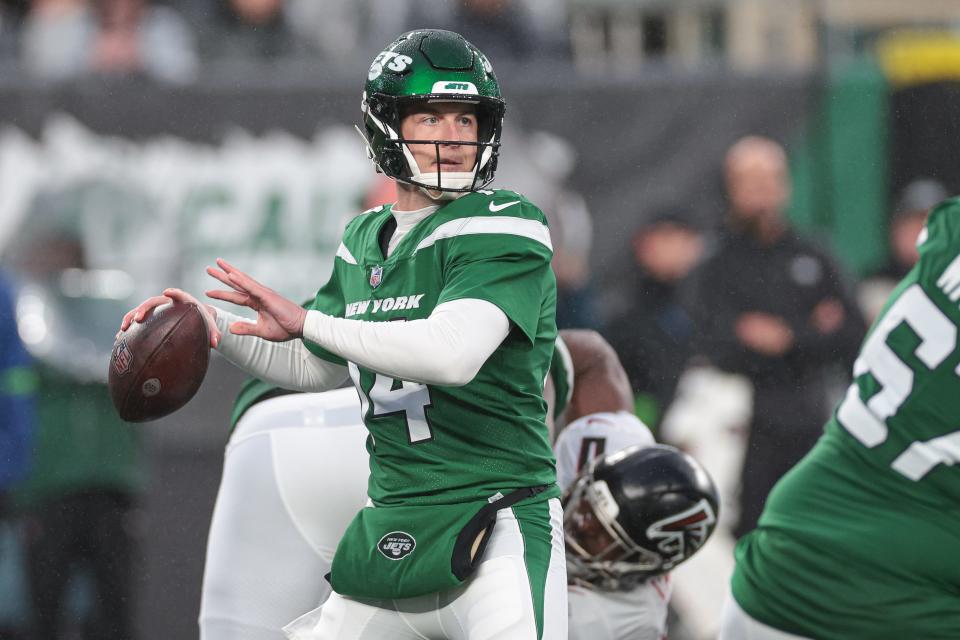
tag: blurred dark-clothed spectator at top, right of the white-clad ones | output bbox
[201,0,308,60]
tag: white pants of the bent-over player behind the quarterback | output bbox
[200,389,369,640]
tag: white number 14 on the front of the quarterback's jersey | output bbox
[347,362,433,444]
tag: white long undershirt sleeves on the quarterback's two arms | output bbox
[217,299,510,391]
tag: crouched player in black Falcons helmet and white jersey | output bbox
[554,331,719,640]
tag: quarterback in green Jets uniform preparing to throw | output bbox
[122,30,566,639]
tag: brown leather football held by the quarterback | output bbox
[107,302,210,422]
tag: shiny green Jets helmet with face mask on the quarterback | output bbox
[358,29,505,198]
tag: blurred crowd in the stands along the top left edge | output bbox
[0,0,568,83]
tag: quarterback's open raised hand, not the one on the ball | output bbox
[207,258,307,342]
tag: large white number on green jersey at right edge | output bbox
[837,284,960,481]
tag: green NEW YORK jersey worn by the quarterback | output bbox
[305,191,557,506]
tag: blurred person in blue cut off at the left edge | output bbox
[0,268,36,638]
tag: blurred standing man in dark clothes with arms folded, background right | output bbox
[688,136,864,536]
